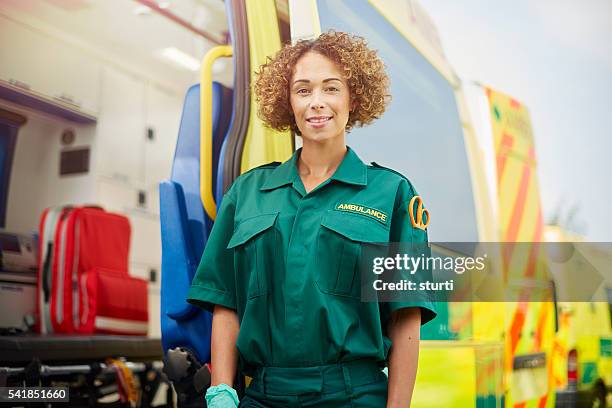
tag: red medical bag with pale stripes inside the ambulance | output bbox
[37,207,148,335]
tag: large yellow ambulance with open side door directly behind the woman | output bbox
[0,0,584,407]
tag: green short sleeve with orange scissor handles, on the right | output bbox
[381,180,436,326]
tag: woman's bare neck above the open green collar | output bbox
[298,137,347,180]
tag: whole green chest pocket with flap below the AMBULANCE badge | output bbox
[315,211,389,298]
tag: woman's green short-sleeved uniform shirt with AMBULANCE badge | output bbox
[187,148,435,374]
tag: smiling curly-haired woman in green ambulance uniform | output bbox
[188,32,435,407]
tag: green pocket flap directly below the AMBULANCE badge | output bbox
[321,211,389,243]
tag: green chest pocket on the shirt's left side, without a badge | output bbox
[227,213,280,299]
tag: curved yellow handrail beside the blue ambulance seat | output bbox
[200,45,232,221]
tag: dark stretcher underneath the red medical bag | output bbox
[0,334,167,407]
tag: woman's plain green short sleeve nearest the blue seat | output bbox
[187,189,236,313]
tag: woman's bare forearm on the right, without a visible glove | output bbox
[387,307,421,408]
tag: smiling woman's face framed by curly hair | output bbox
[289,52,351,142]
